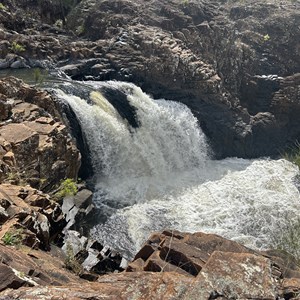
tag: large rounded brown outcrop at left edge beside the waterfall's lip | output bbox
[0,78,80,190]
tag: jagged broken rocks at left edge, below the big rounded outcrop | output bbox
[0,184,65,249]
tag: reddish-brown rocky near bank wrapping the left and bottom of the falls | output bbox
[0,78,300,300]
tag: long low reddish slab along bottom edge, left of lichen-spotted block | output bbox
[0,272,199,300]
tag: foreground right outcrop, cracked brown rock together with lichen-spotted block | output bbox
[127,231,300,299]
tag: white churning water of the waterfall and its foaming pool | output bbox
[56,82,300,258]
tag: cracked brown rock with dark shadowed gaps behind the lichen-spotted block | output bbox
[127,230,255,276]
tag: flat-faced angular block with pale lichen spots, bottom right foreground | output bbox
[197,251,277,299]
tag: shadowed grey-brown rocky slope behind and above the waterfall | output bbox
[0,0,300,157]
